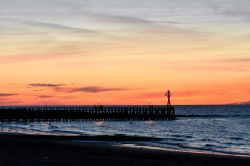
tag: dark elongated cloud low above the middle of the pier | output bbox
[70,86,129,93]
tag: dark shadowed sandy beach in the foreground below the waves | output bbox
[0,134,250,166]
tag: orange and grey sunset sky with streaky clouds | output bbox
[0,0,250,105]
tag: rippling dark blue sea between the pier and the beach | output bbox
[0,105,250,157]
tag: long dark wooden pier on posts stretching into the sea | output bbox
[0,105,175,121]
